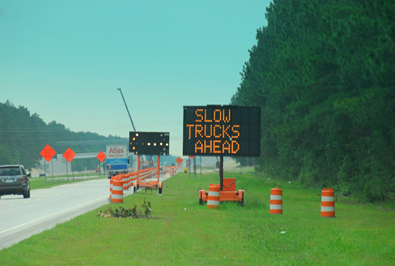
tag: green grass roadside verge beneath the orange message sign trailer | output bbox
[0,171,395,265]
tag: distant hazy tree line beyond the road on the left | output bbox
[0,101,124,171]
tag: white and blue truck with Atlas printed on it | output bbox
[106,145,129,179]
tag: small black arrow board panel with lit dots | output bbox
[129,131,170,155]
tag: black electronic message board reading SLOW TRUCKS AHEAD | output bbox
[183,105,261,157]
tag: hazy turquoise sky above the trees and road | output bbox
[0,0,270,155]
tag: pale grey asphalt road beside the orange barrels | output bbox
[0,174,172,250]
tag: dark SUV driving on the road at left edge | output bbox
[0,164,30,198]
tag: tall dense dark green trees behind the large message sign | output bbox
[235,0,395,202]
